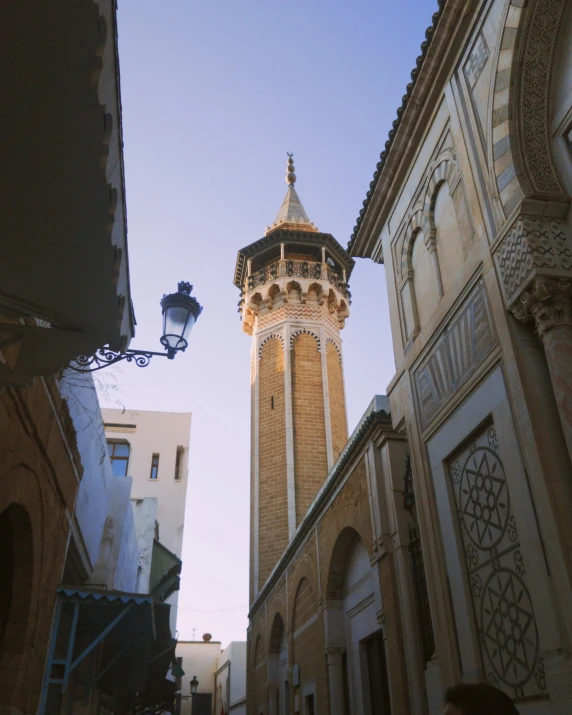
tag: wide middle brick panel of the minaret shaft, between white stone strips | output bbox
[291,334,328,524]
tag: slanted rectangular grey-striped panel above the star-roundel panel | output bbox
[414,283,495,427]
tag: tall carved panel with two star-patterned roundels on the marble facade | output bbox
[448,424,546,700]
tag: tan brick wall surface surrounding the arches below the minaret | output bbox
[247,436,411,715]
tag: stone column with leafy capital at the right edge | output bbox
[512,276,572,459]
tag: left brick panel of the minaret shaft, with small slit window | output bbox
[258,338,288,588]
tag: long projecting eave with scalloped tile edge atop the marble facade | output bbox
[348,0,480,258]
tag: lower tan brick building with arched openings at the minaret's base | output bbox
[247,406,432,715]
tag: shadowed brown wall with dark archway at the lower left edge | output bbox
[0,379,80,713]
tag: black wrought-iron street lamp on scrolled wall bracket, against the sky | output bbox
[69,281,203,374]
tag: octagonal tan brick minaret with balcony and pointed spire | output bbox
[234,154,354,601]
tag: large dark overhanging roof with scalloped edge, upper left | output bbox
[0,0,134,386]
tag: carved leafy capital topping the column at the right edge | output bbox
[511,275,572,339]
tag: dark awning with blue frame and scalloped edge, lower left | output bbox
[38,586,176,715]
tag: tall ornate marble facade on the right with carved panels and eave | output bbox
[350,0,572,715]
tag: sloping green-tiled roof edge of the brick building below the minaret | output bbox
[248,395,391,619]
